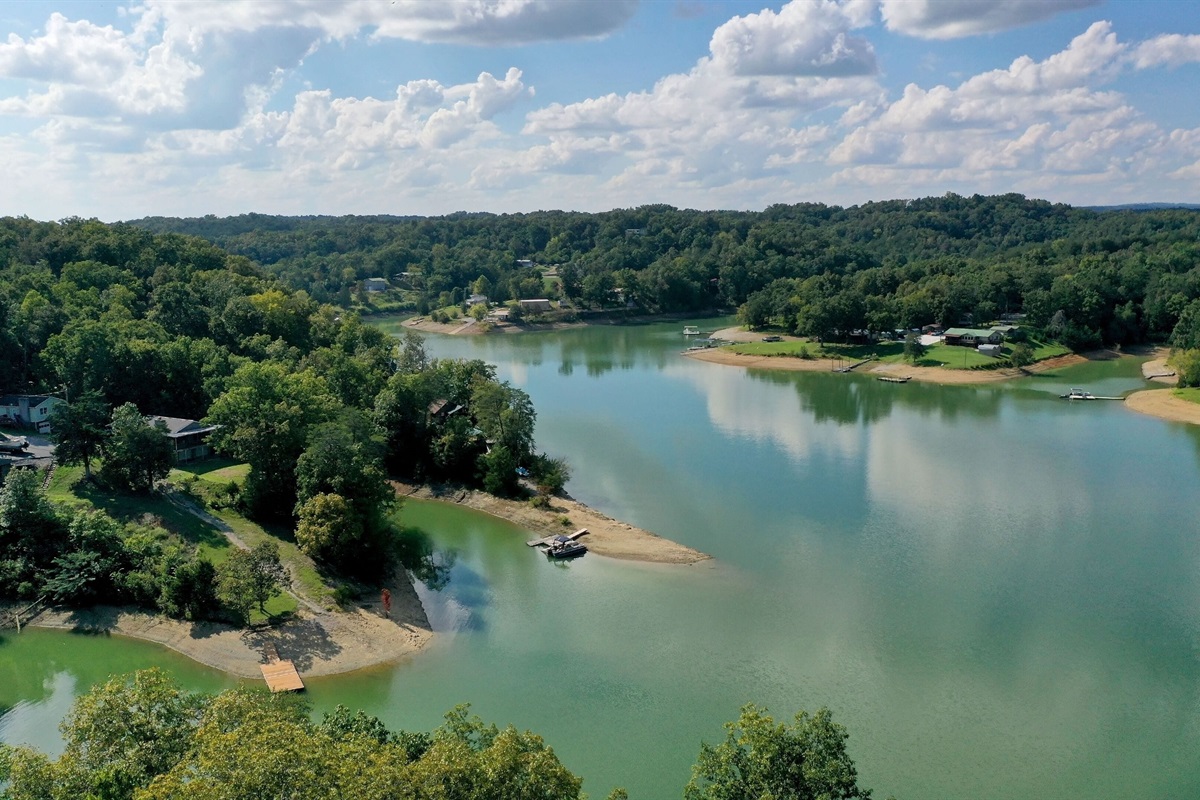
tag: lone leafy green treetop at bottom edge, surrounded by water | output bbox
[684,705,871,800]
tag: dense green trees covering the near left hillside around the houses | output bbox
[0,218,556,609]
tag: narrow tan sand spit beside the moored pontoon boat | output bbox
[392,481,712,564]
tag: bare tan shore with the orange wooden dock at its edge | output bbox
[24,571,433,680]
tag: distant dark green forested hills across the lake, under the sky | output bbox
[132,194,1200,348]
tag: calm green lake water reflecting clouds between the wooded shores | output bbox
[0,320,1200,800]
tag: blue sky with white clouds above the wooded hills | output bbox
[0,0,1200,221]
